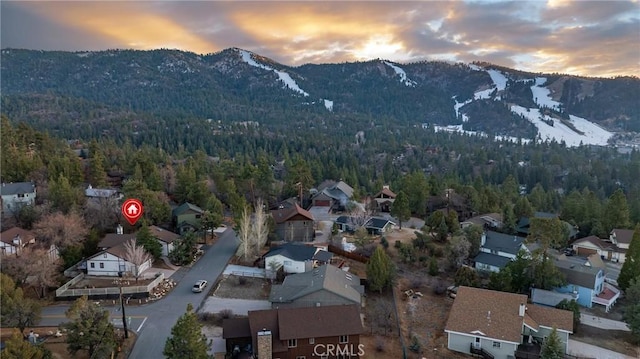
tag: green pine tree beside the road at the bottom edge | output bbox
[162,303,210,359]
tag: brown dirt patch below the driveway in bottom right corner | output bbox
[571,324,640,358]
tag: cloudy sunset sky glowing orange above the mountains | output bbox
[0,0,640,77]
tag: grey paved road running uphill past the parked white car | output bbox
[40,229,238,359]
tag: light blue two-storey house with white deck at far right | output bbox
[554,258,620,311]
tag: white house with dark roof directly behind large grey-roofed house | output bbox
[264,243,333,276]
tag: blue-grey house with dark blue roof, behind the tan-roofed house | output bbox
[473,231,529,272]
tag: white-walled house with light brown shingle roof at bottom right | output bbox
[445,287,573,359]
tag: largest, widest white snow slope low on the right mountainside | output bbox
[511,105,613,147]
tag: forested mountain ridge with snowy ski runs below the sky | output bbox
[0,48,640,145]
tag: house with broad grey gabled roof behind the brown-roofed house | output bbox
[269,264,364,309]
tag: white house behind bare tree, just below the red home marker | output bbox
[87,243,152,277]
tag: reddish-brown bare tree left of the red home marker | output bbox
[33,211,89,247]
